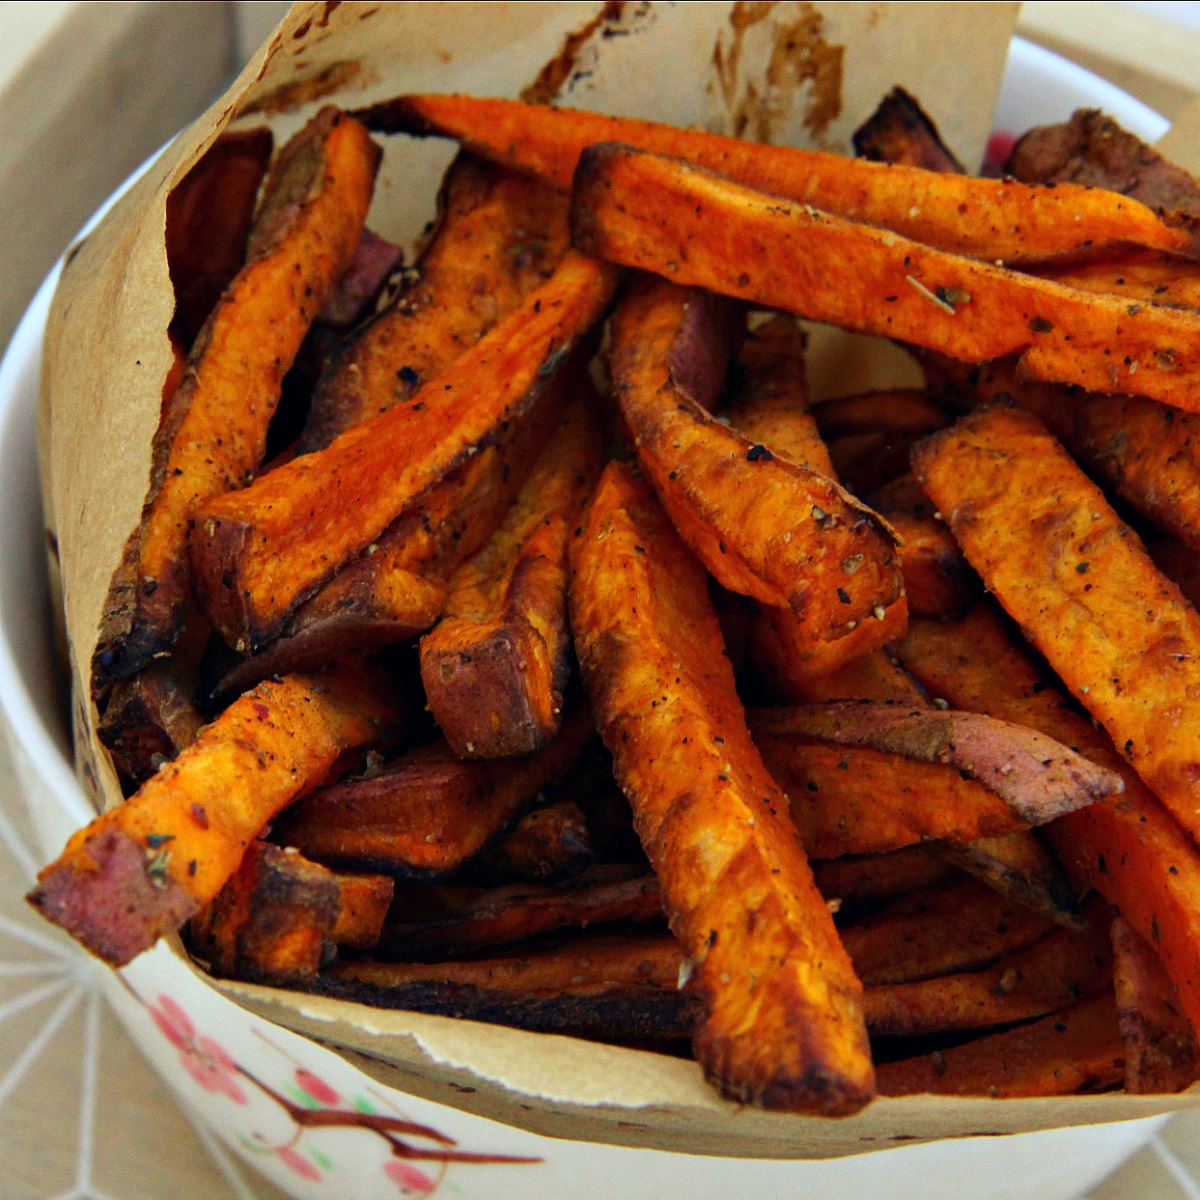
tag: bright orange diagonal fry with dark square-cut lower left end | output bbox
[191,253,618,648]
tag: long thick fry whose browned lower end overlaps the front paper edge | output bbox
[571,463,872,1115]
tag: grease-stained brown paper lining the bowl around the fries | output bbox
[41,2,1196,1157]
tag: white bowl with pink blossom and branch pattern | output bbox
[0,32,1168,1200]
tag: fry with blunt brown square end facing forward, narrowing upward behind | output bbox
[421,388,604,758]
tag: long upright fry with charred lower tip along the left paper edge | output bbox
[94,108,379,690]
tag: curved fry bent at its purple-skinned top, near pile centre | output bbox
[611,278,906,673]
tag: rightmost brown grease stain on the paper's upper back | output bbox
[713,0,845,143]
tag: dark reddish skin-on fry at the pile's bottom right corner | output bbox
[1112,917,1200,1096]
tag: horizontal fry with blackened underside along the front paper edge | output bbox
[317,934,697,1040]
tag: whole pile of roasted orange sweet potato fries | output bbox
[30,84,1200,1116]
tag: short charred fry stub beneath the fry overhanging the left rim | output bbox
[188,841,340,985]
